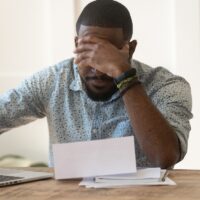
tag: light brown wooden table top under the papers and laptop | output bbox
[0,168,200,200]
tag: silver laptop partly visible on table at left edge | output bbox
[0,168,53,187]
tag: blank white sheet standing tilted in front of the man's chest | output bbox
[53,136,136,179]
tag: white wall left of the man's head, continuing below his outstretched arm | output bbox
[0,0,74,162]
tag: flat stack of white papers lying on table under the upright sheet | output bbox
[79,168,176,188]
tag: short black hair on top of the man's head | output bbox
[76,0,133,40]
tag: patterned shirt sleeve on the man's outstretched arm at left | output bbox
[0,71,50,133]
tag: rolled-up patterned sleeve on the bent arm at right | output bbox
[152,70,193,160]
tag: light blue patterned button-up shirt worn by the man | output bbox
[0,59,192,167]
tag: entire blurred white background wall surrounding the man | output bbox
[0,0,200,169]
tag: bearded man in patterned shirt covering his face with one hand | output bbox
[0,0,192,168]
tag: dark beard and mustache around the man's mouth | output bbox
[83,76,118,101]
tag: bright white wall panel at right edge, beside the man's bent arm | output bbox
[174,0,200,169]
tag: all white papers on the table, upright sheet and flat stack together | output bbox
[53,136,175,188]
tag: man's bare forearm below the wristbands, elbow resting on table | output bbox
[123,85,180,168]
